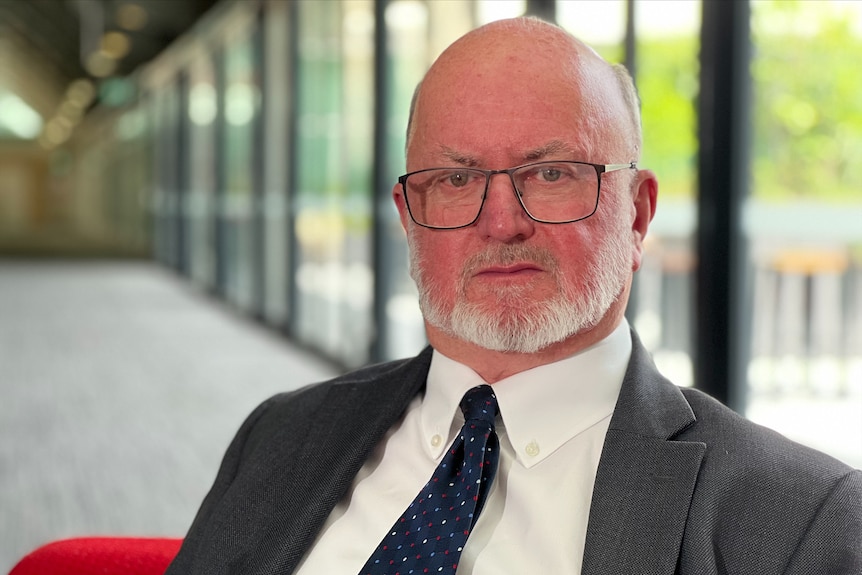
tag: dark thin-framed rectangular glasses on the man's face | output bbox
[398,162,637,230]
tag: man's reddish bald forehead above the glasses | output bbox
[408,34,612,169]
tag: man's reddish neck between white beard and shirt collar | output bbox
[425,297,627,383]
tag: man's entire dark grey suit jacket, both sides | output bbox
[167,334,862,575]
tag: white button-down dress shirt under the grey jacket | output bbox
[297,320,631,575]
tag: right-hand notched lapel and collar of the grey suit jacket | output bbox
[581,333,706,575]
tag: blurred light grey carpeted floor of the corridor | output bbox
[0,259,344,573]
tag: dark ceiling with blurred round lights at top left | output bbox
[0,0,217,137]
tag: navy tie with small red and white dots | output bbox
[359,385,499,575]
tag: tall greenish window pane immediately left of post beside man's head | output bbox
[292,0,374,366]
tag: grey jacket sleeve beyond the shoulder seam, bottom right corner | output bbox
[784,469,862,575]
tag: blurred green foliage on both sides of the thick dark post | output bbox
[637,0,862,202]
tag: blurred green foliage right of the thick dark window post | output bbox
[751,0,862,204]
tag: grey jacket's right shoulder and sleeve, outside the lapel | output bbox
[674,389,862,575]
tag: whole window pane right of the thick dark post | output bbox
[744,1,862,467]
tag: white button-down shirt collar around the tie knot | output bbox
[420,320,632,468]
